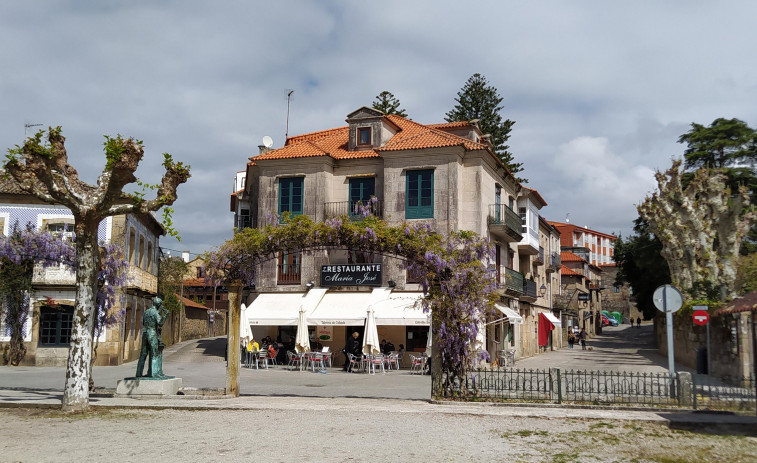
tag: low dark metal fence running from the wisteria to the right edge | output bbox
[442,368,756,411]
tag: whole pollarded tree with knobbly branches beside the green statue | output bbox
[4,127,189,411]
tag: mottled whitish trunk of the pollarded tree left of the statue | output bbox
[63,227,100,412]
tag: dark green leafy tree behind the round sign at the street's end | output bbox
[613,218,670,320]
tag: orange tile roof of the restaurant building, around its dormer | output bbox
[250,114,494,162]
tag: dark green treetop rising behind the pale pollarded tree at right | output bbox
[678,117,757,169]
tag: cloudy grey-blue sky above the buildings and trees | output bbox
[0,0,757,253]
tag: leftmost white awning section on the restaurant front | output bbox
[247,288,326,326]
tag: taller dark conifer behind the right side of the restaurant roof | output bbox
[445,74,527,183]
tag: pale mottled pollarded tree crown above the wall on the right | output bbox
[638,160,757,299]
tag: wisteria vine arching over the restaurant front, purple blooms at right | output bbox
[205,205,496,393]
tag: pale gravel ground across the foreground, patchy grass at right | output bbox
[0,399,757,463]
